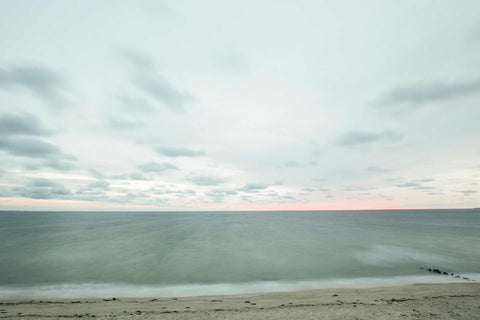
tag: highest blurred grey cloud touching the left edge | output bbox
[0,65,64,106]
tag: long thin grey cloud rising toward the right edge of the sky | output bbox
[372,79,480,106]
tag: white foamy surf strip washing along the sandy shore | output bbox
[0,274,474,299]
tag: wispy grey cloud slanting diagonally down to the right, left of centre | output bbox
[122,51,192,112]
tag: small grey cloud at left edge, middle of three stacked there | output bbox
[0,113,52,136]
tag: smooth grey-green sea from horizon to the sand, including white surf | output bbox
[0,210,480,297]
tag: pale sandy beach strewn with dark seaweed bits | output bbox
[0,283,480,320]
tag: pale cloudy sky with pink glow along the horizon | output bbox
[0,0,480,211]
